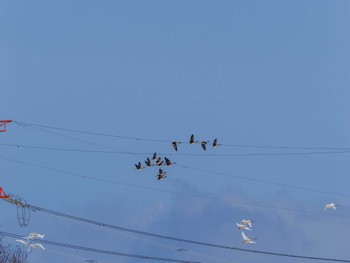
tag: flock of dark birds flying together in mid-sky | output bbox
[135,134,220,180]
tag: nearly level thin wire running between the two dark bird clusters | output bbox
[0,143,350,157]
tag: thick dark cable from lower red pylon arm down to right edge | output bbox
[0,204,350,263]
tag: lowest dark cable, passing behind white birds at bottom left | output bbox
[0,231,200,263]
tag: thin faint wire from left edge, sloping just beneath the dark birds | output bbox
[0,156,350,218]
